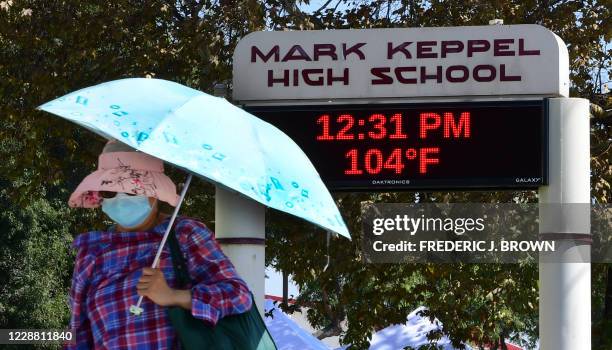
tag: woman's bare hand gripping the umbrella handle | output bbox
[136,267,191,310]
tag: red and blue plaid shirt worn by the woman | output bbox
[66,218,252,349]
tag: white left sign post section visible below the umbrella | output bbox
[215,186,266,316]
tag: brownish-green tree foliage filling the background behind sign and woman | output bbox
[0,0,612,349]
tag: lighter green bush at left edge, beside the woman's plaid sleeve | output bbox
[0,198,74,329]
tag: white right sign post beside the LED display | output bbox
[539,98,591,350]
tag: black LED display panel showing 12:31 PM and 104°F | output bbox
[246,101,547,191]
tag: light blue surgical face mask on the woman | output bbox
[102,193,153,228]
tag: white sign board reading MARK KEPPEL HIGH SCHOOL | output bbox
[233,24,569,104]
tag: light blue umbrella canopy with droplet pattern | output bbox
[39,78,350,238]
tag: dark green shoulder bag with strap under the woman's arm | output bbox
[168,227,276,350]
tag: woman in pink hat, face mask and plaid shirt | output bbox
[67,141,253,349]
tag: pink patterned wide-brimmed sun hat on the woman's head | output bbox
[68,140,179,208]
